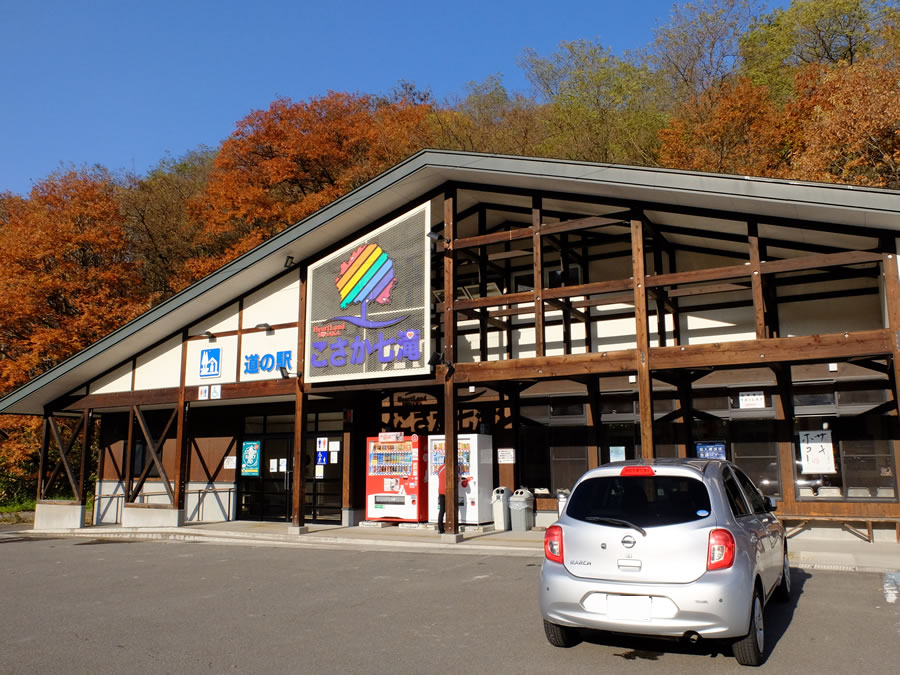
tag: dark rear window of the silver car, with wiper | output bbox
[566,476,710,527]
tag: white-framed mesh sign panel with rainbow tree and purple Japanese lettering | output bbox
[303,203,431,382]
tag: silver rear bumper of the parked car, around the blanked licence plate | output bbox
[540,561,753,638]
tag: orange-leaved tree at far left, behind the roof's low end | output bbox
[0,170,147,498]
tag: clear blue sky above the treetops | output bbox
[0,0,732,194]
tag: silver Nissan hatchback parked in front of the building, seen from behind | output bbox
[540,459,791,666]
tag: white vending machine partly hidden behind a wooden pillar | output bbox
[428,434,494,525]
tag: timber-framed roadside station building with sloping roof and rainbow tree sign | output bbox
[0,151,900,540]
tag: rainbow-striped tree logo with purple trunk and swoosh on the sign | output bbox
[332,244,406,328]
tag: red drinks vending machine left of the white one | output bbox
[366,432,428,523]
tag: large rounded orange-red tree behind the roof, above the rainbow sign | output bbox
[188,92,431,277]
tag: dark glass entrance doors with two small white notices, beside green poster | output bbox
[237,434,294,521]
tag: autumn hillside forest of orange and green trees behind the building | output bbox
[0,0,900,504]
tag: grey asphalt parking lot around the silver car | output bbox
[0,531,900,674]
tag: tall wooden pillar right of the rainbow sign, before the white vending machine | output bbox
[444,187,459,534]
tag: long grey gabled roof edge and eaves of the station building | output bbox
[0,150,900,415]
